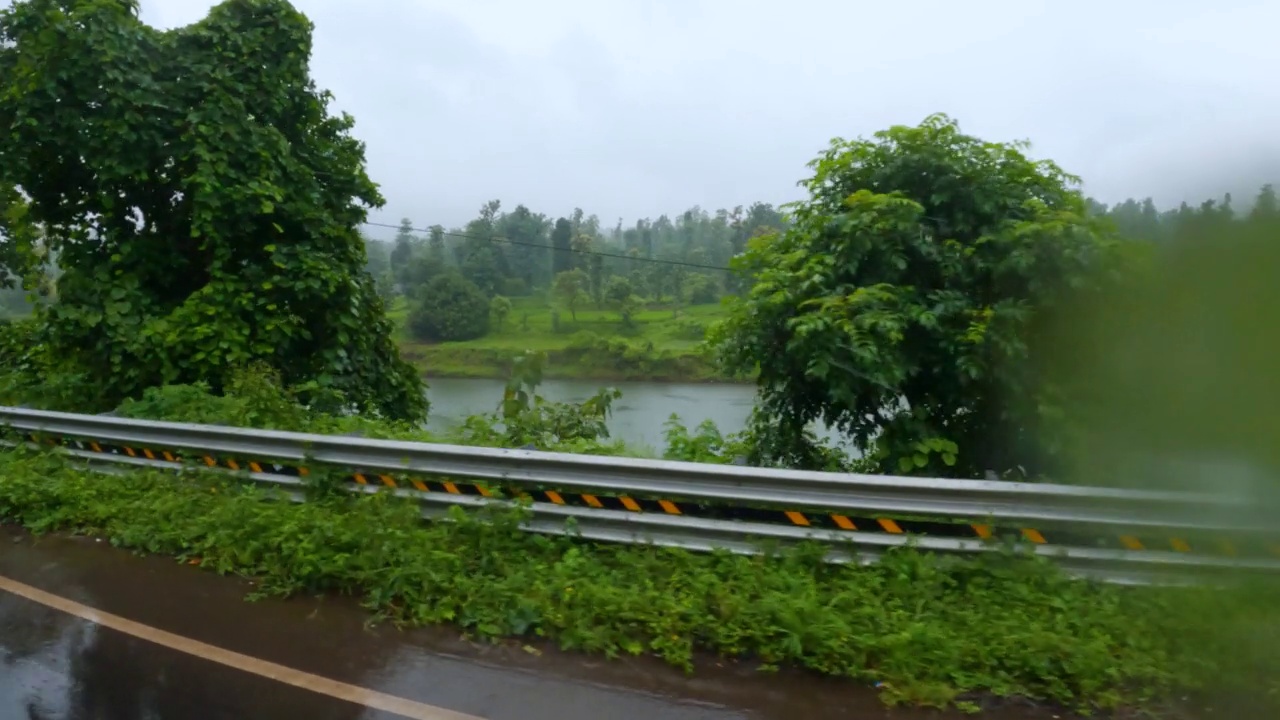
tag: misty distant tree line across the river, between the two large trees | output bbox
[367,200,786,341]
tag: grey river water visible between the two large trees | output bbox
[426,378,755,452]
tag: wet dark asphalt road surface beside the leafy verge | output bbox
[0,520,1080,720]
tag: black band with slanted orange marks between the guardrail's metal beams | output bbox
[28,433,1280,556]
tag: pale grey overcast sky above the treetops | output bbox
[142,0,1280,234]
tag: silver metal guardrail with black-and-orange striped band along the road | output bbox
[0,407,1280,583]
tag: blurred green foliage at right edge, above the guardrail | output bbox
[1056,209,1280,491]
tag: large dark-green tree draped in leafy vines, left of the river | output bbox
[0,0,426,419]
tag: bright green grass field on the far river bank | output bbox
[388,296,731,382]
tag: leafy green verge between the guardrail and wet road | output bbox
[0,451,1280,708]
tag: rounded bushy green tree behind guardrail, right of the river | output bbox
[718,115,1116,475]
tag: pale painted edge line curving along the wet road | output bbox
[0,575,484,720]
